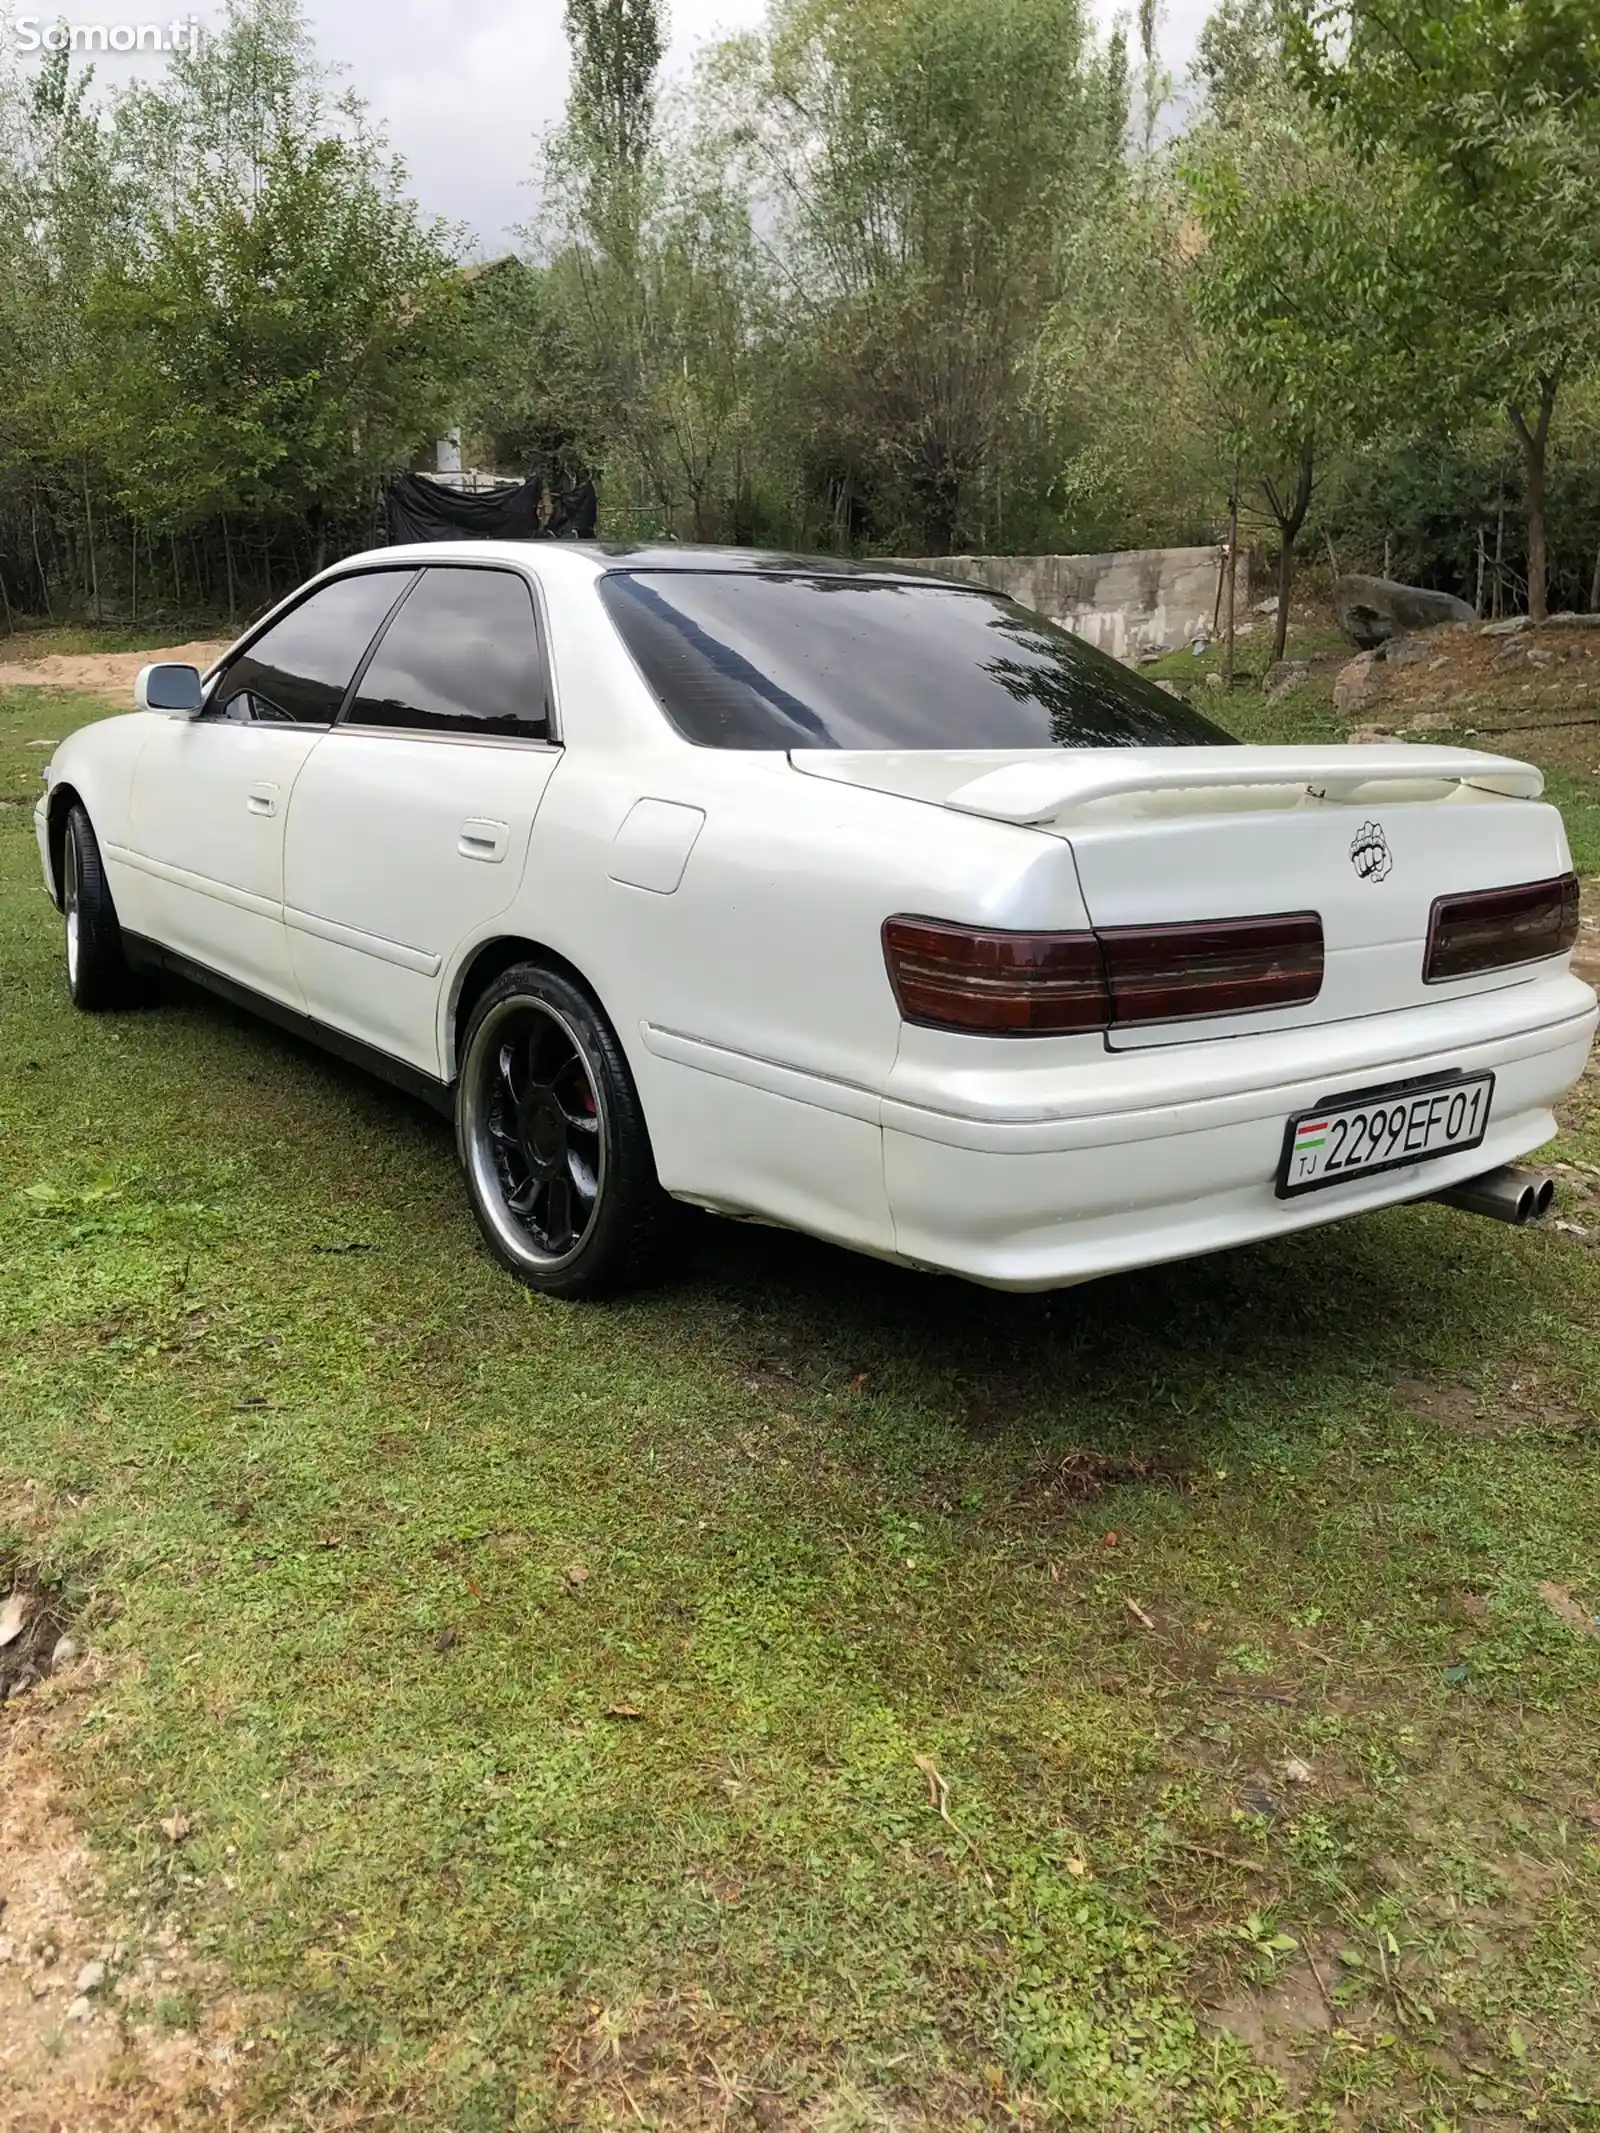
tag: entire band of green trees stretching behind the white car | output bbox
[0,0,1600,623]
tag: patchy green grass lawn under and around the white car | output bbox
[0,639,1600,2133]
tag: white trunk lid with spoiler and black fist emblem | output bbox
[791,744,1570,1049]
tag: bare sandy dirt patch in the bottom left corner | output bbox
[0,1657,250,2133]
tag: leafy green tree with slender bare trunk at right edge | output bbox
[1286,0,1600,621]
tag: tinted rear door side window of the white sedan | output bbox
[350,565,550,740]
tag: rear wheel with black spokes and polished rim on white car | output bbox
[457,962,672,1297]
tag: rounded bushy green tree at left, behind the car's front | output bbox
[83,122,467,597]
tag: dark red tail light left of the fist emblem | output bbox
[883,911,1323,1037]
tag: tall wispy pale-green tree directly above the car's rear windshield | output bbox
[721,0,1126,552]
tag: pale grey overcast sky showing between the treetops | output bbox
[0,0,1207,254]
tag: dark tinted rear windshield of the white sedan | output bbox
[599,570,1233,749]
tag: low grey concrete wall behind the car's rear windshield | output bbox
[905,548,1250,659]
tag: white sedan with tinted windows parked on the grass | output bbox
[38,542,1596,1297]
